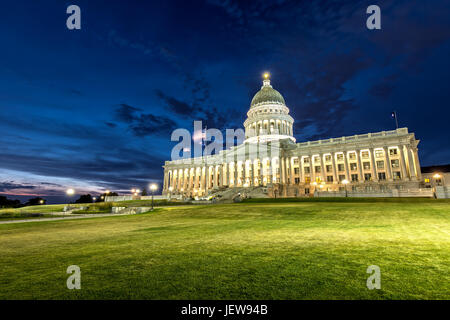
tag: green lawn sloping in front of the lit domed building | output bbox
[0,199,450,299]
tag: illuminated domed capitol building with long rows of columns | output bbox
[163,74,422,197]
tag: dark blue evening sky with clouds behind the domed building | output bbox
[0,0,450,201]
